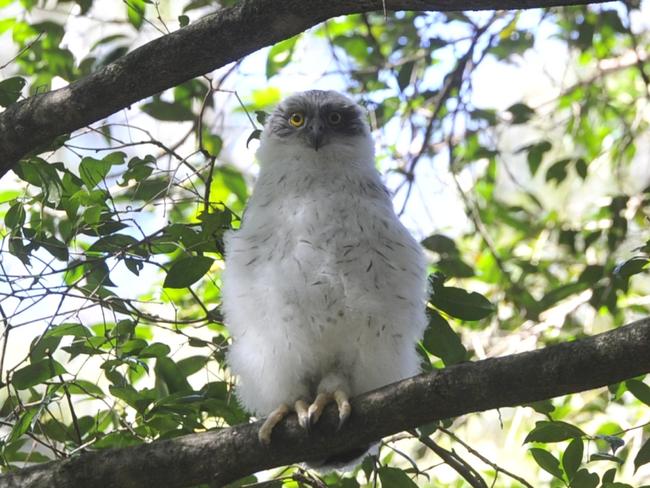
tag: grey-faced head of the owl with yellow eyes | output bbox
[264,90,370,152]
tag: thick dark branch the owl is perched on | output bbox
[0,318,650,488]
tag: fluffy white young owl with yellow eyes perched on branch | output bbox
[222,90,426,466]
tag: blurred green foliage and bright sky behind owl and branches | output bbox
[0,0,650,488]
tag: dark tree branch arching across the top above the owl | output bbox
[0,0,606,177]
